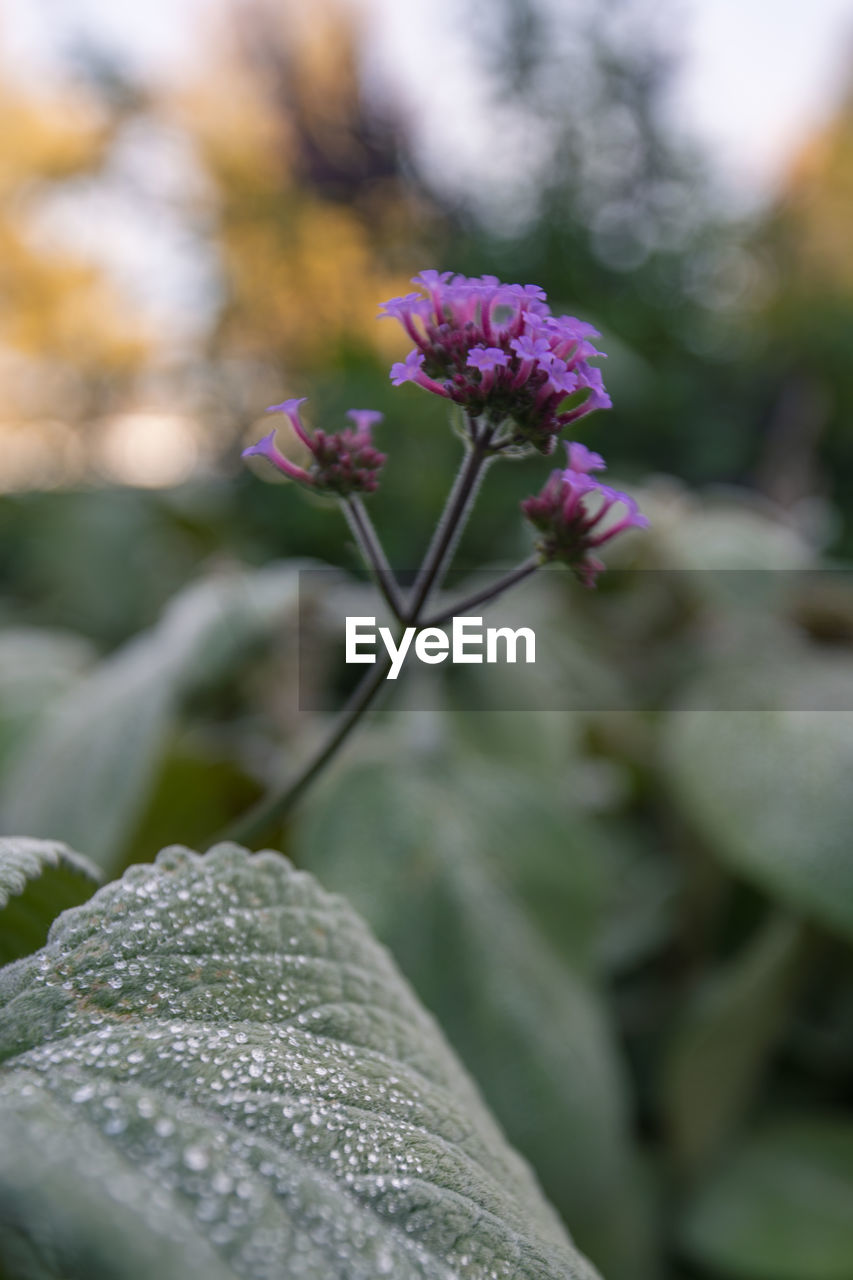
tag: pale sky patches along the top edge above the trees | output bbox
[6,0,853,205]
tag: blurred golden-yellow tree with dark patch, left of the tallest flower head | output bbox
[176,0,434,379]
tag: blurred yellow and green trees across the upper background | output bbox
[0,0,853,550]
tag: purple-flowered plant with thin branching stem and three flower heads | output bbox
[234,269,648,838]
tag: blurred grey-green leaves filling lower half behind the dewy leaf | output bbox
[0,467,853,1280]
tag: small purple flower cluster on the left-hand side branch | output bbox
[243,397,386,498]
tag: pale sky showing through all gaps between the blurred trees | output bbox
[0,0,853,344]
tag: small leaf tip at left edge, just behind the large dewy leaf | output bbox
[0,836,101,964]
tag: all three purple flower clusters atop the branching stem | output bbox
[243,270,648,586]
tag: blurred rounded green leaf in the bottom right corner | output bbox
[683,1116,853,1280]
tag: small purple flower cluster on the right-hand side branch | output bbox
[521,443,648,586]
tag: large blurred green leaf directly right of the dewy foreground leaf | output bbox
[292,755,644,1280]
